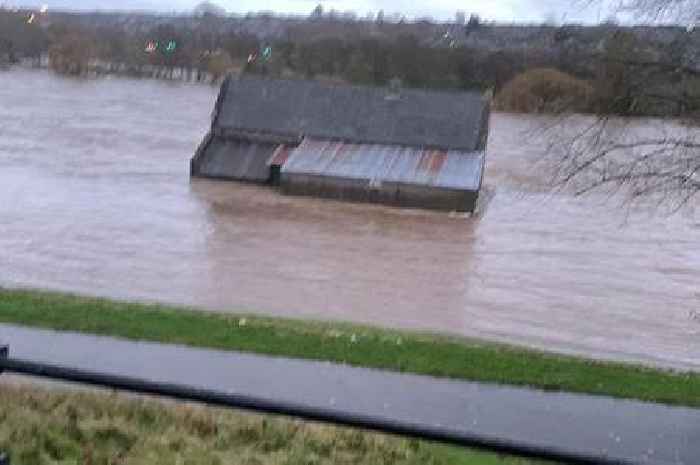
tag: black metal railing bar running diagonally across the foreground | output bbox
[0,348,632,465]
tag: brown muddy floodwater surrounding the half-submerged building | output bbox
[0,71,700,369]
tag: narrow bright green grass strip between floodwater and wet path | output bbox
[0,290,700,407]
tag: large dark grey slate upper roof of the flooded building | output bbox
[213,77,489,151]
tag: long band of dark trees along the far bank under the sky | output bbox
[0,10,700,116]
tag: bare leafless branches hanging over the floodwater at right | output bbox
[549,116,700,210]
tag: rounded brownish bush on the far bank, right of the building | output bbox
[495,68,594,113]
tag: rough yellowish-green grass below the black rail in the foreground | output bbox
[0,384,534,465]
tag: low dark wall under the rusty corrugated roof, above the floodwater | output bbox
[280,173,479,212]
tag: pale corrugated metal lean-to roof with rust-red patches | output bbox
[282,139,485,191]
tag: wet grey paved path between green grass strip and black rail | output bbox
[0,325,700,465]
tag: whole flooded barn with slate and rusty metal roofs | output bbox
[191,77,490,212]
